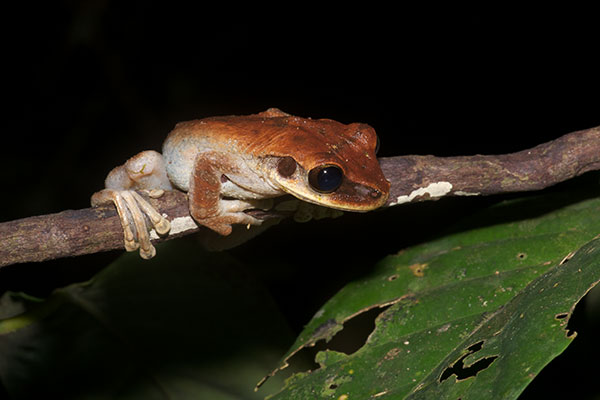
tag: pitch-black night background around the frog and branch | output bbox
[0,1,600,398]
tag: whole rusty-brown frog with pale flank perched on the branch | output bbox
[91,108,390,259]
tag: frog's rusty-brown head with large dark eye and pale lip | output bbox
[265,116,390,211]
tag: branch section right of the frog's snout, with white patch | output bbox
[379,127,600,206]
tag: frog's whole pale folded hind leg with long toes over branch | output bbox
[92,151,172,259]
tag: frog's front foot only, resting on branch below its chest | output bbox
[192,199,273,236]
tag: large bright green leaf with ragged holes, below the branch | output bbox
[264,195,600,400]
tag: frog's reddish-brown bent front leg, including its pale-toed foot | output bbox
[188,152,273,236]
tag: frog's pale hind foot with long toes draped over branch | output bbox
[92,189,171,259]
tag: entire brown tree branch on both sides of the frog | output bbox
[0,127,600,267]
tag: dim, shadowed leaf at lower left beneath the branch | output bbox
[0,240,293,400]
